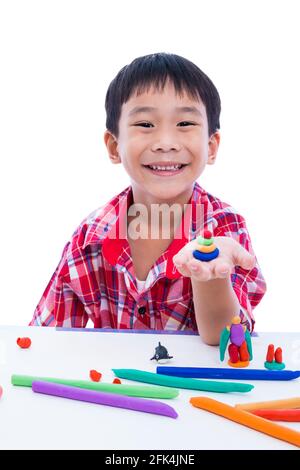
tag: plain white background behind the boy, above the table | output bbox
[0,0,300,332]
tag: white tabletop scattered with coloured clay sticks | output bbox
[0,326,300,450]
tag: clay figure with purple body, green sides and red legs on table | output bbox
[220,316,252,367]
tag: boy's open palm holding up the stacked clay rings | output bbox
[173,237,256,281]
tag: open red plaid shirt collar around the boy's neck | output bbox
[83,182,214,279]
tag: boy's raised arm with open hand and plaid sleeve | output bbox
[174,212,266,344]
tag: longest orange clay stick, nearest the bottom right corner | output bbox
[190,397,300,447]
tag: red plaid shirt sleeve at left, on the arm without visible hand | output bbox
[29,242,88,328]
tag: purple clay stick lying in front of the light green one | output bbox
[32,381,178,418]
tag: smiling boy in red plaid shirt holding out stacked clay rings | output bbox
[30,53,266,344]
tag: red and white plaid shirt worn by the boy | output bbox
[30,182,266,331]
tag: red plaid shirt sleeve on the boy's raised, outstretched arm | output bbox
[214,207,266,331]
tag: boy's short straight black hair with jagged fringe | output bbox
[105,52,221,137]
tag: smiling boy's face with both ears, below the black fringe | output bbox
[104,83,220,202]
